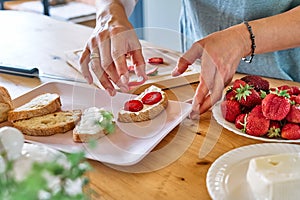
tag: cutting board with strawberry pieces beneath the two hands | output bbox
[66,41,201,94]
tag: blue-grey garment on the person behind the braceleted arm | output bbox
[180,0,300,82]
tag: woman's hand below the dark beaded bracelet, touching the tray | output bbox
[172,24,251,119]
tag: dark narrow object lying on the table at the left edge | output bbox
[0,65,39,78]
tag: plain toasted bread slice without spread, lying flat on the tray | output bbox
[13,110,81,136]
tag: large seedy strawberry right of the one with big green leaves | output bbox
[262,93,291,121]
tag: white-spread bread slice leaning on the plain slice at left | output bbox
[8,93,61,122]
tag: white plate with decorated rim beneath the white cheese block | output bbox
[206,143,300,200]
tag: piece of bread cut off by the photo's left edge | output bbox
[0,86,13,122]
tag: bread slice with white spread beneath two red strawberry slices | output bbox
[118,85,168,122]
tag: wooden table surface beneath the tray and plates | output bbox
[0,11,300,200]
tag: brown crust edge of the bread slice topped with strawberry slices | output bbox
[118,85,168,122]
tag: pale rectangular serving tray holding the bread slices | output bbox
[8,82,191,165]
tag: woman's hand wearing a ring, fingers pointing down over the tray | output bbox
[80,4,147,96]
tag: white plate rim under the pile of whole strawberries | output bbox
[212,101,300,143]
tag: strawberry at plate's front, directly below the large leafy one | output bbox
[246,105,270,136]
